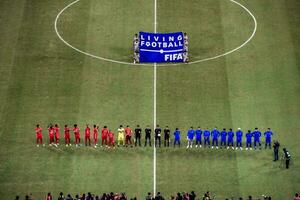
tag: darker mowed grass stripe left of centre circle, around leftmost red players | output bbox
[0,1,92,198]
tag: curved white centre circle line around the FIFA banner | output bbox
[54,0,257,66]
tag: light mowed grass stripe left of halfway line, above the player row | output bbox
[62,1,153,127]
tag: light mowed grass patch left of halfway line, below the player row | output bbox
[62,148,152,198]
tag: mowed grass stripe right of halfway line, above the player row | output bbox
[158,1,236,129]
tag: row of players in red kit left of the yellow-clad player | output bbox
[35,124,119,148]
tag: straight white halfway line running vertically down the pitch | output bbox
[153,0,157,196]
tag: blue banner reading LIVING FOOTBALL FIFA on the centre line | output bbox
[139,32,184,62]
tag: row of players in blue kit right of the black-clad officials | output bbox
[178,127,273,150]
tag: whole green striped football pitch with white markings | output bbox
[0,0,300,200]
